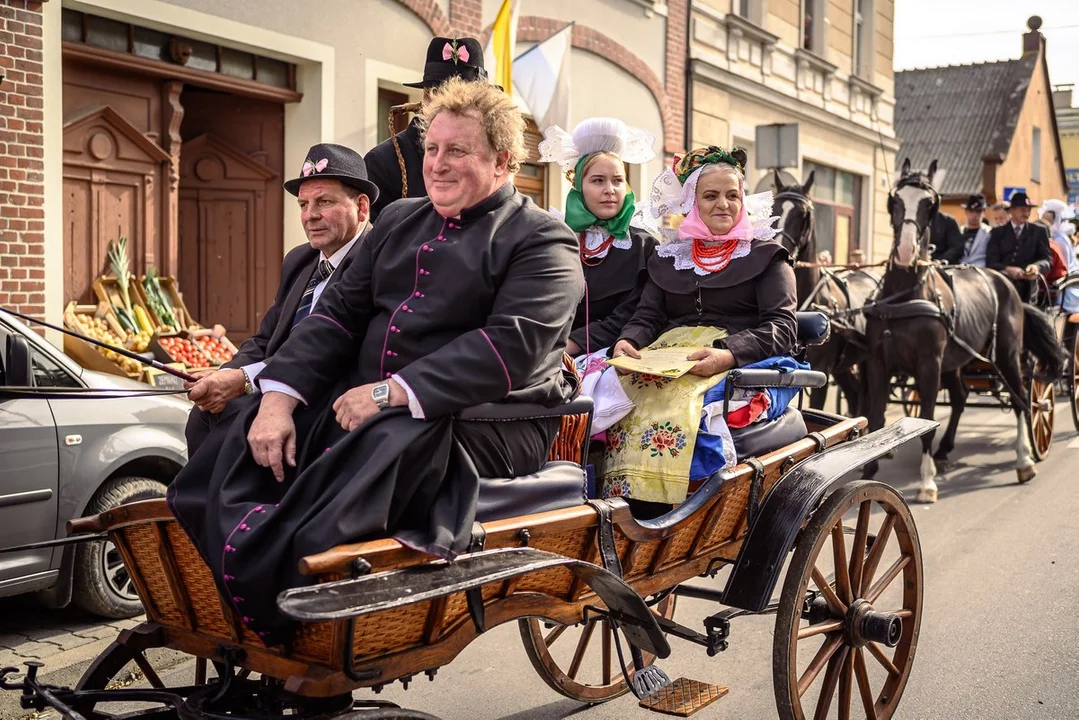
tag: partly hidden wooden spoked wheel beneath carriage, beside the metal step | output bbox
[518,595,675,703]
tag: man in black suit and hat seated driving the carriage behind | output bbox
[985,192,1053,302]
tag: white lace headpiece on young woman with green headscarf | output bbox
[540,118,656,172]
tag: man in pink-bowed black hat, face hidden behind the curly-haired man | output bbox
[364,38,487,220]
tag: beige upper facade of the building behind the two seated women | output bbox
[689,0,898,259]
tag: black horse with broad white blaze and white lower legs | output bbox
[865,160,1064,502]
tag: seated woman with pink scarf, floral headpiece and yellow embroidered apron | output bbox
[603,146,797,514]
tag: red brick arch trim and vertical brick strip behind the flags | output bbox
[397,0,689,155]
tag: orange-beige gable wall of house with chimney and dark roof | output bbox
[994,49,1067,204]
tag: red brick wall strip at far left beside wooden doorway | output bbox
[0,0,45,316]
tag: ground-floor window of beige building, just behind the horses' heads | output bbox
[802,161,862,263]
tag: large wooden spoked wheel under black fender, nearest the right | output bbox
[773,480,923,720]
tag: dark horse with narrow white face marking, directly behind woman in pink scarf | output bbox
[773,172,880,416]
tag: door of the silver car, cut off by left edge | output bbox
[0,323,59,595]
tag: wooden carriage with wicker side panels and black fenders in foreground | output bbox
[0,313,935,720]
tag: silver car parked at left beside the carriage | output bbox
[0,311,191,617]
